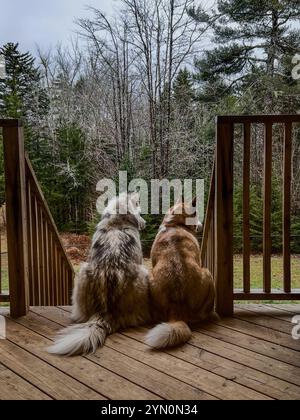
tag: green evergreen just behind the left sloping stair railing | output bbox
[46,123,95,233]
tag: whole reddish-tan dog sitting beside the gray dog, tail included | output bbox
[146,201,216,349]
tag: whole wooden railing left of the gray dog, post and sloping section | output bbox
[0,120,74,317]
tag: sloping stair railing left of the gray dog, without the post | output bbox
[25,156,74,306]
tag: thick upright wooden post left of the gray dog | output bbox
[3,120,29,318]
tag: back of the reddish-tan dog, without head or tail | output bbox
[150,227,214,322]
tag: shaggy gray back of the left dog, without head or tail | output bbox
[73,215,142,322]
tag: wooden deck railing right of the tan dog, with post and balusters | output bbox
[201,115,300,315]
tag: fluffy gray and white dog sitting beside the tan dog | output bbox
[48,193,150,356]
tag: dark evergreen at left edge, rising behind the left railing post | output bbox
[0,43,49,181]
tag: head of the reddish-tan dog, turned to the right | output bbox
[163,198,202,233]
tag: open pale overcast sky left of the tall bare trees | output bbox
[0,0,118,53]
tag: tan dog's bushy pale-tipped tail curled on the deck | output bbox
[145,321,192,349]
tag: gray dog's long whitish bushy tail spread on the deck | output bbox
[48,316,110,356]
